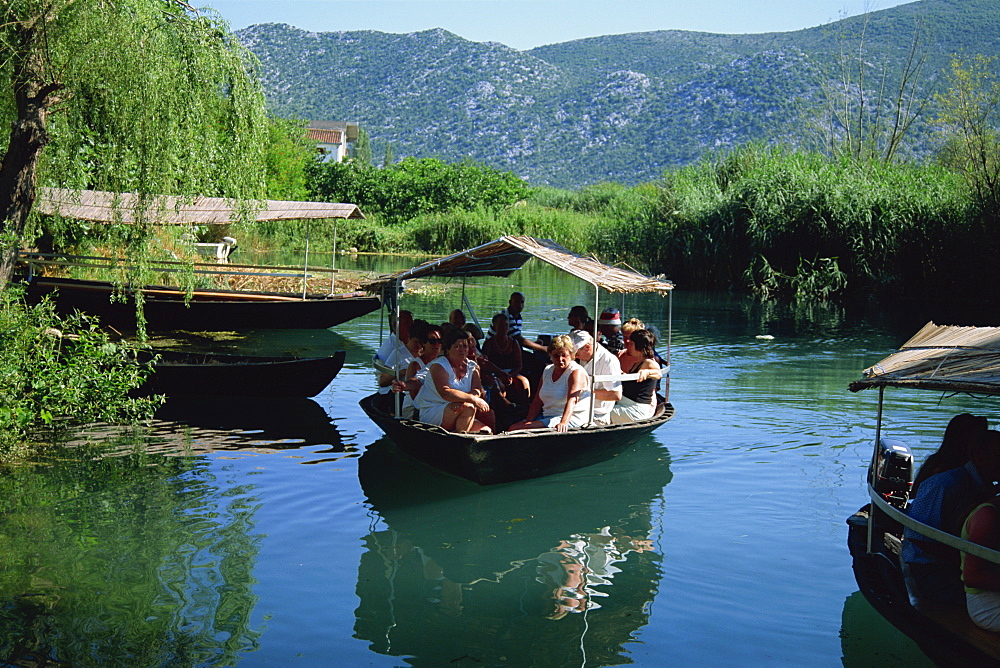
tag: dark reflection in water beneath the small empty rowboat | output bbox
[149,397,355,463]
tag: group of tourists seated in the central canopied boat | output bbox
[377,292,664,433]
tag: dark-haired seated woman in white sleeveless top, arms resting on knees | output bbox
[414,329,494,433]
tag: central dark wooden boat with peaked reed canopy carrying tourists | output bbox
[360,236,674,485]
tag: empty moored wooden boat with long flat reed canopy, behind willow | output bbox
[22,188,380,331]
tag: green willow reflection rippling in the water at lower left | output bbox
[0,448,262,666]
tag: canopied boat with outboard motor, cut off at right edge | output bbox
[847,322,1000,666]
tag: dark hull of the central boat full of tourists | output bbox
[360,394,674,485]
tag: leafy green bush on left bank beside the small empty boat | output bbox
[0,288,159,459]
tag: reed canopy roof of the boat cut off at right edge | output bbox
[850,322,1000,394]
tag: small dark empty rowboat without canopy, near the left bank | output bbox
[135,350,347,397]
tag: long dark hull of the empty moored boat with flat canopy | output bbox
[28,277,381,332]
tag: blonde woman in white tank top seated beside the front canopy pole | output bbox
[508,334,590,431]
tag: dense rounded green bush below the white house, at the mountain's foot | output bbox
[310,158,528,223]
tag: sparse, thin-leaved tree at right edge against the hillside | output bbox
[937,56,1000,215]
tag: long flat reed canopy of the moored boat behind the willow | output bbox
[35,188,364,225]
